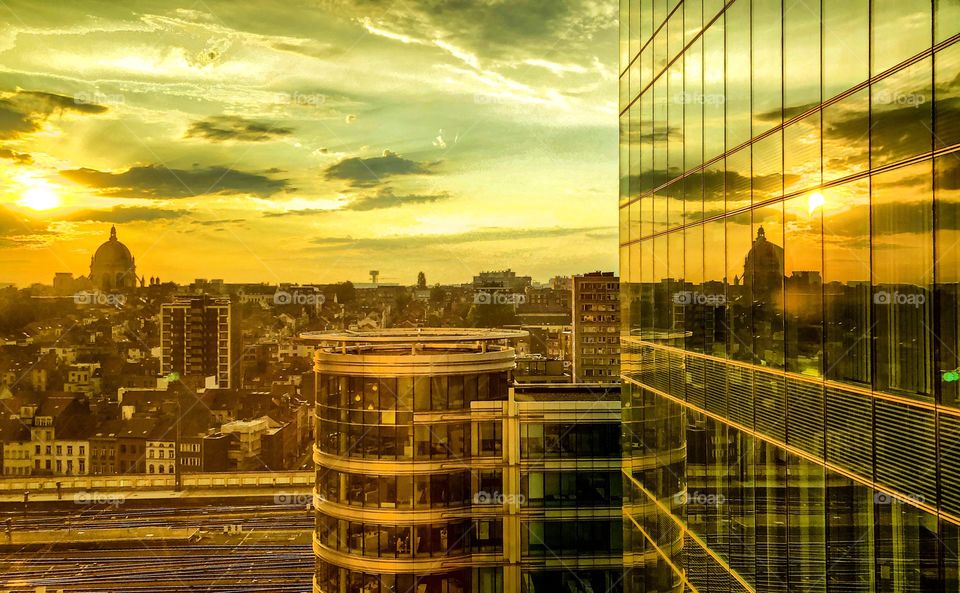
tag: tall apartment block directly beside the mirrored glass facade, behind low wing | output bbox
[570,272,620,383]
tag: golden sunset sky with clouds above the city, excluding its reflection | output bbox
[0,0,618,285]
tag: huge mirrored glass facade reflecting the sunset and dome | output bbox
[619,0,960,593]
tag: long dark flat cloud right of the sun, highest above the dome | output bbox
[60,165,288,200]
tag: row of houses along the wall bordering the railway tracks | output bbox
[0,387,312,476]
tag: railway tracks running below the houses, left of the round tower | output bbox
[0,505,314,593]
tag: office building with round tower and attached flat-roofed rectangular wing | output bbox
[303,329,623,593]
